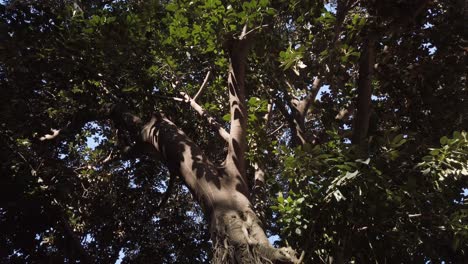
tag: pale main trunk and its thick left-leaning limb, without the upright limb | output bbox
[141,114,297,264]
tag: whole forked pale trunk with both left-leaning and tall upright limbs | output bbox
[136,35,298,264]
